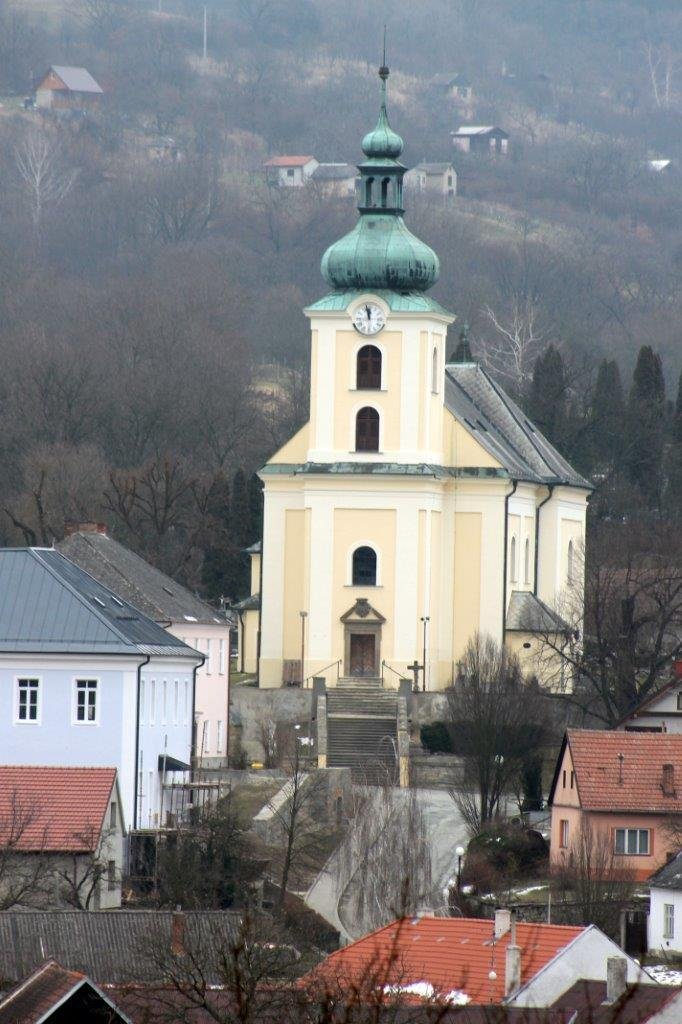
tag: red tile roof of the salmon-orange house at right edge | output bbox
[549,729,682,814]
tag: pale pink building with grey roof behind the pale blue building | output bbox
[56,522,231,767]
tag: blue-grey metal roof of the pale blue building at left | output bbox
[0,548,201,659]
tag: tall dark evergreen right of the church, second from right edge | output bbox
[626,345,666,508]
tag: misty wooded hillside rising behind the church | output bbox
[0,0,682,596]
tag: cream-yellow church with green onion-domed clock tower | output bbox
[238,67,591,690]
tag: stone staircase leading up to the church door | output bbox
[326,677,399,785]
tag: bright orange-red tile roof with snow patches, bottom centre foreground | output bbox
[302,918,585,1004]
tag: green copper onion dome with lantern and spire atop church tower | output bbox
[322,67,440,292]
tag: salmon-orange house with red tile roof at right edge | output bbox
[549,729,682,881]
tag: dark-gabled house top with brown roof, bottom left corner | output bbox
[0,959,132,1024]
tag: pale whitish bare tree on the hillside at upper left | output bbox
[14,129,78,238]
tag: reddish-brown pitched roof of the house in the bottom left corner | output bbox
[0,959,130,1024]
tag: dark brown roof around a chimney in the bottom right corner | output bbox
[551,981,682,1024]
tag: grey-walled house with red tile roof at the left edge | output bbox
[0,765,125,913]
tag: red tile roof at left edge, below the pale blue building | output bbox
[0,765,116,853]
